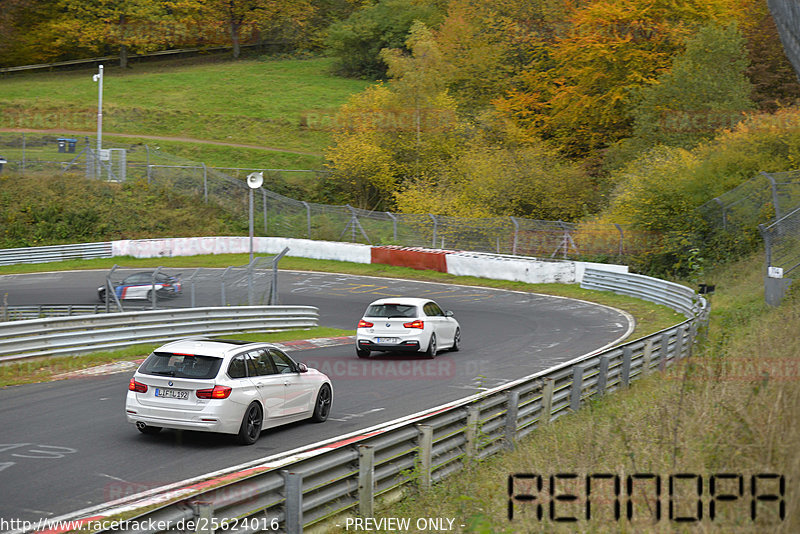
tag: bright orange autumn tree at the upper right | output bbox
[496,0,732,157]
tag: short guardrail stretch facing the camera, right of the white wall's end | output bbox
[581,269,700,318]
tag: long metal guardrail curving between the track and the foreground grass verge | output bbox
[64,272,708,534]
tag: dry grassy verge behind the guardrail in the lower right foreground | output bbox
[322,256,800,534]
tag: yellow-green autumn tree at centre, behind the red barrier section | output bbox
[327,22,458,209]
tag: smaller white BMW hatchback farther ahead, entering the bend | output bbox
[356,298,461,358]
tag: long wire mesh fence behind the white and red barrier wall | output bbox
[0,134,660,261]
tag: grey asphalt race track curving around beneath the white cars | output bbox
[0,271,629,521]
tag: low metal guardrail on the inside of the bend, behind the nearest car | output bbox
[0,306,319,362]
